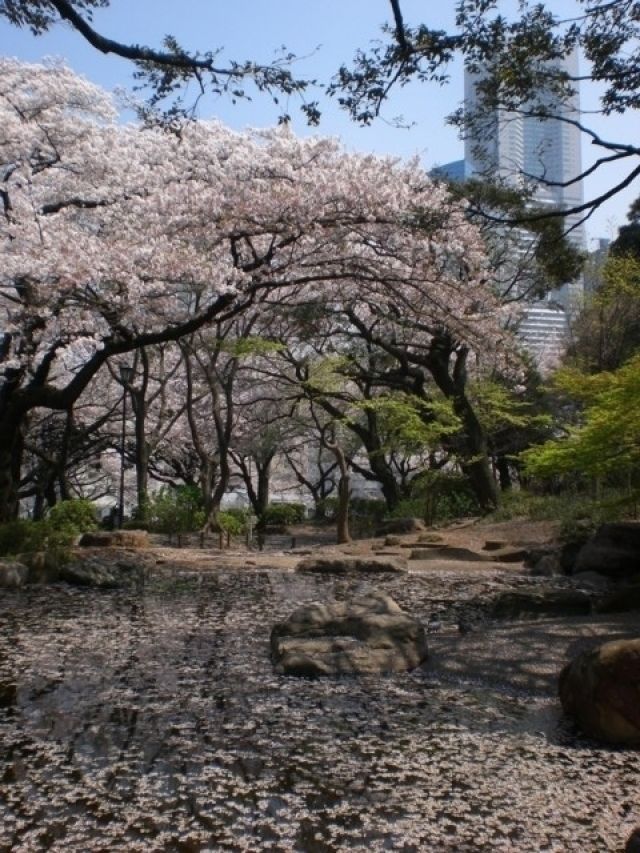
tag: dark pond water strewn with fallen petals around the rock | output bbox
[0,570,640,853]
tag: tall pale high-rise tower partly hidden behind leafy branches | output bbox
[432,54,586,360]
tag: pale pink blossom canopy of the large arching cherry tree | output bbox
[0,60,506,519]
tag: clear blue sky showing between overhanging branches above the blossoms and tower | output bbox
[0,0,640,239]
